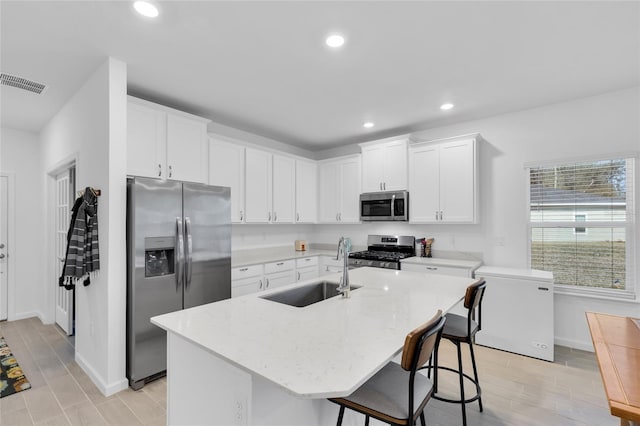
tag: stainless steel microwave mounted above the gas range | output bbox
[360,191,409,221]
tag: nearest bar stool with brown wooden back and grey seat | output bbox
[329,311,445,426]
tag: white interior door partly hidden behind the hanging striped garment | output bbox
[54,169,75,336]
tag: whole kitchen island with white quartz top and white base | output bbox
[151,268,473,425]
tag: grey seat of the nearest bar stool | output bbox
[335,362,433,424]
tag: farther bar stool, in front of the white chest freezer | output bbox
[426,278,487,426]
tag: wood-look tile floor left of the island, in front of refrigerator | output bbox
[0,318,167,426]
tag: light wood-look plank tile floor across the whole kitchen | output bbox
[0,318,620,426]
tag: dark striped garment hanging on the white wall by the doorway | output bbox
[59,187,100,290]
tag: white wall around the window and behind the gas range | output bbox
[307,87,640,350]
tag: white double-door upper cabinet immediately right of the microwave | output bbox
[409,134,479,223]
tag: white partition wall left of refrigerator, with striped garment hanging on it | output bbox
[41,59,127,395]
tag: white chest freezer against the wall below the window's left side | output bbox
[475,266,554,362]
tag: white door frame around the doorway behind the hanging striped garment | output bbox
[44,153,80,324]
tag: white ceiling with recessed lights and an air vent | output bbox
[0,0,640,151]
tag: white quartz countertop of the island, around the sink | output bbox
[151,268,472,398]
